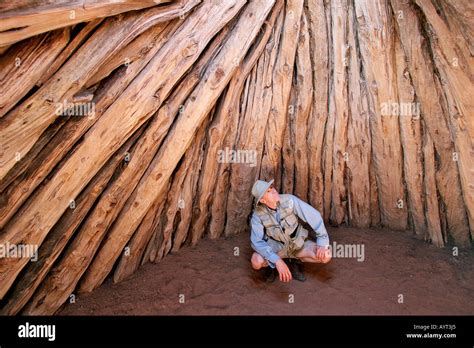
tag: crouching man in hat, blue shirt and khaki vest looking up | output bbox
[250,180,331,282]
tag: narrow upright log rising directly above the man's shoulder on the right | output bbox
[305,0,330,214]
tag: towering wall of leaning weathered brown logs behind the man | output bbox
[0,0,474,315]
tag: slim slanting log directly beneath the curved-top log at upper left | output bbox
[0,21,180,227]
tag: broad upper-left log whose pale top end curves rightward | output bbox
[0,2,193,179]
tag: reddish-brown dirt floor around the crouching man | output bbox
[59,228,474,315]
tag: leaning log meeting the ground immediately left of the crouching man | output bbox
[224,7,283,236]
